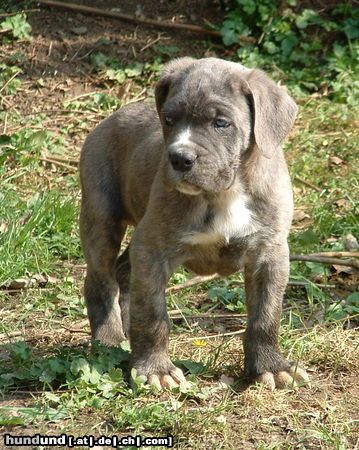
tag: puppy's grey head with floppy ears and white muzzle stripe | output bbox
[156,58,297,195]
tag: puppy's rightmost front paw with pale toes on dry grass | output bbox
[255,365,310,391]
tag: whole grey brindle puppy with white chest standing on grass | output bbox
[80,58,308,389]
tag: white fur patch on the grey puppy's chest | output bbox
[183,196,258,245]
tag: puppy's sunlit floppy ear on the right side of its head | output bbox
[247,69,298,158]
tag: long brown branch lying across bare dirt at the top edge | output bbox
[38,0,254,43]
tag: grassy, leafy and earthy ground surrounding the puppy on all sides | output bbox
[0,0,359,450]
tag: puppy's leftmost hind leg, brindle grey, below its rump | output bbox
[80,201,126,346]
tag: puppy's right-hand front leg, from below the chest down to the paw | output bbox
[244,243,309,389]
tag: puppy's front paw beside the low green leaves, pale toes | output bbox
[133,359,187,390]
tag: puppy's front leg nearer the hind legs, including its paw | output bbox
[130,237,186,389]
